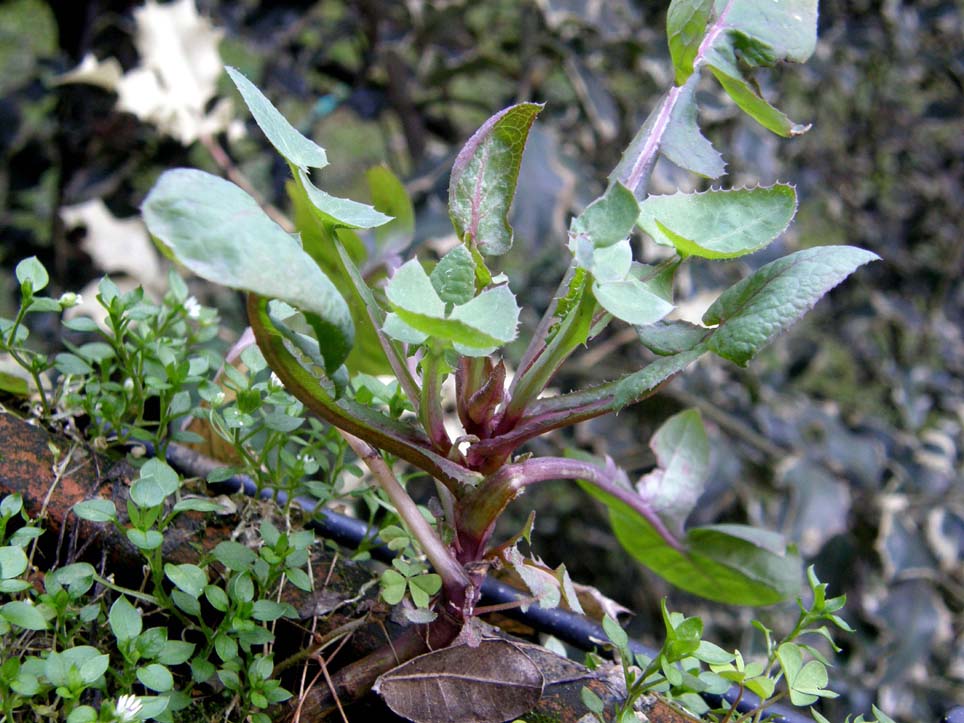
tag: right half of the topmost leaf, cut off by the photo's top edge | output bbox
[705,0,817,136]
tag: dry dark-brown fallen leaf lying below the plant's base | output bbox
[374,639,543,723]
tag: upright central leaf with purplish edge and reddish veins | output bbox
[449,103,542,256]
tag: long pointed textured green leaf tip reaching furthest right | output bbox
[703,246,879,365]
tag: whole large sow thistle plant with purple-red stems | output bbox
[136,0,876,718]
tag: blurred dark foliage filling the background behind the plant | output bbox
[0,0,964,720]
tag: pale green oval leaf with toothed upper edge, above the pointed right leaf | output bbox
[639,184,797,259]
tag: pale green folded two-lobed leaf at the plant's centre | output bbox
[383,259,519,356]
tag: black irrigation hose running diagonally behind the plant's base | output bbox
[156,444,813,723]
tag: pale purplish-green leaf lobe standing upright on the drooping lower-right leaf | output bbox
[636,409,710,534]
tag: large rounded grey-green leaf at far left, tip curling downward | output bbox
[142,168,355,375]
